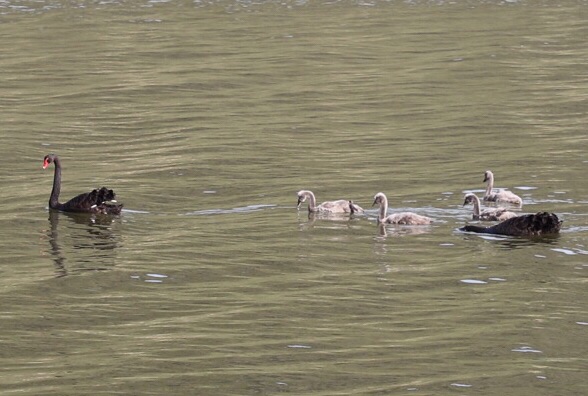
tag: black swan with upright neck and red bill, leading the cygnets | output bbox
[43,154,123,214]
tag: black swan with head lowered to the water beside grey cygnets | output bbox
[460,212,562,236]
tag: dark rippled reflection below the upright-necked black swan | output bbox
[47,210,119,278]
